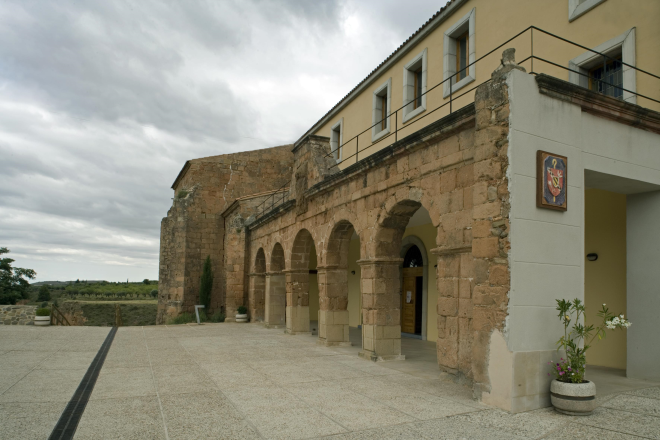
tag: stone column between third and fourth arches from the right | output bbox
[284,269,312,335]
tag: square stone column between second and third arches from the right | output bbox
[317,266,353,346]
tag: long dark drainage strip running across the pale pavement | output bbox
[48,327,117,440]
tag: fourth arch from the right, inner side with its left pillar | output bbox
[264,242,286,328]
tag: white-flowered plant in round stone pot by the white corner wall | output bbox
[548,299,631,416]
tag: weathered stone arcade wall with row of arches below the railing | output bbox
[249,72,509,387]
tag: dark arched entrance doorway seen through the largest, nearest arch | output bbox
[401,246,424,336]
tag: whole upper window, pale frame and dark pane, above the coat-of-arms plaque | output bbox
[568,28,637,104]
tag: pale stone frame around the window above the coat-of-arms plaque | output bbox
[568,28,637,104]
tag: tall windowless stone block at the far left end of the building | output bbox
[157,145,293,324]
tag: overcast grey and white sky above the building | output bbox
[0,0,446,281]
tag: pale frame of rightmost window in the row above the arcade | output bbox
[442,8,477,98]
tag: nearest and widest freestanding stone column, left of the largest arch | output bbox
[357,258,406,362]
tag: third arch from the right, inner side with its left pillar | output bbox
[285,229,316,335]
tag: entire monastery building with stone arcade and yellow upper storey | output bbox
[158,0,660,412]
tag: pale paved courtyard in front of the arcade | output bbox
[0,323,660,440]
